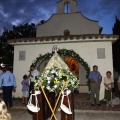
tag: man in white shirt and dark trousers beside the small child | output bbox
[29,65,39,97]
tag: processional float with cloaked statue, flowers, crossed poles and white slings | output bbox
[27,46,79,120]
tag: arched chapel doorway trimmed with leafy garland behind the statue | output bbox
[32,49,90,92]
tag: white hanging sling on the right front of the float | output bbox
[60,89,72,114]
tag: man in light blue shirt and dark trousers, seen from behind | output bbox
[0,66,16,108]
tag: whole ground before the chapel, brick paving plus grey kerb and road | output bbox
[9,94,120,120]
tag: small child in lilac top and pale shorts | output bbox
[21,75,29,104]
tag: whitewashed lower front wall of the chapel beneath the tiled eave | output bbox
[14,42,113,99]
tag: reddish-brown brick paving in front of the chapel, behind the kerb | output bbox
[13,93,120,111]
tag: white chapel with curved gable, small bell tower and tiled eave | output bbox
[9,0,118,99]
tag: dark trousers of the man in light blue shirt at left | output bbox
[3,86,13,108]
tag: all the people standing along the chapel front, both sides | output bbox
[0,65,120,118]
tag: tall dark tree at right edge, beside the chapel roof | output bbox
[112,16,120,72]
